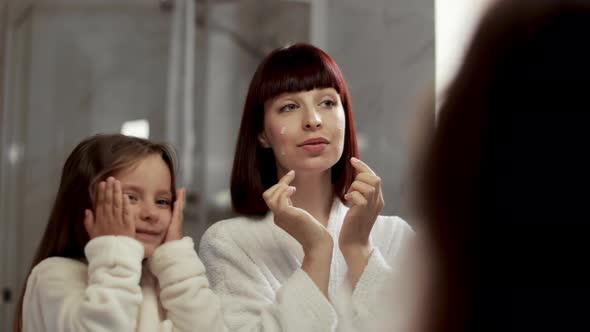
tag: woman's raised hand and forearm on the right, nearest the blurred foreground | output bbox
[338,158,385,284]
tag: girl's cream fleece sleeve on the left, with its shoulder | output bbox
[23,236,144,332]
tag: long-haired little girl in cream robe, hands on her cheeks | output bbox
[14,135,227,332]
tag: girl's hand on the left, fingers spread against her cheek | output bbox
[84,177,135,239]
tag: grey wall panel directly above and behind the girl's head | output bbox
[18,6,169,277]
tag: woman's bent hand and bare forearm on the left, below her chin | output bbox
[262,171,334,255]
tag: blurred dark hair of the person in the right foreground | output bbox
[419,0,590,331]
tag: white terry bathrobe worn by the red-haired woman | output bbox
[199,199,413,332]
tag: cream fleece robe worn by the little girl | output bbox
[22,236,224,332]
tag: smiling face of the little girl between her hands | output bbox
[113,154,174,257]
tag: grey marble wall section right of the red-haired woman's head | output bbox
[327,0,434,214]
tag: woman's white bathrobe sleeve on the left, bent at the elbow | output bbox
[199,225,337,332]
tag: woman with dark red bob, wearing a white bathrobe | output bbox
[200,44,412,332]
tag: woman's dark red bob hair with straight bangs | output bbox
[231,43,359,216]
